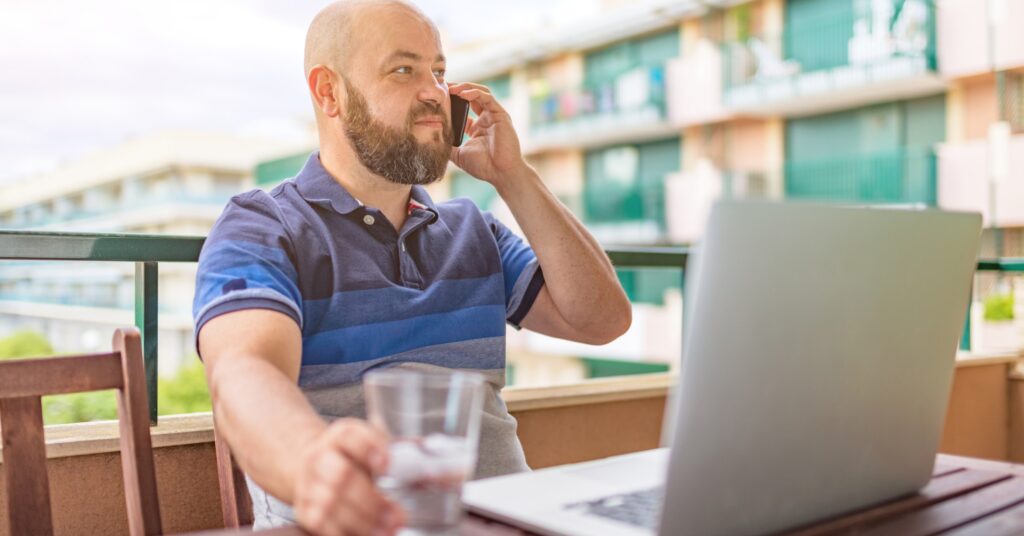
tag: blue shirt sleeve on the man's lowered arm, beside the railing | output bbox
[193,190,302,351]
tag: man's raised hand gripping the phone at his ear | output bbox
[449,83,532,194]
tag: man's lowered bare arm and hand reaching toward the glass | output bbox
[199,310,403,534]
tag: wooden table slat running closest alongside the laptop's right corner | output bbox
[790,467,1010,536]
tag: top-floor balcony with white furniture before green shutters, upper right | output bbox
[722,0,944,117]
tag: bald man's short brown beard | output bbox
[345,76,452,184]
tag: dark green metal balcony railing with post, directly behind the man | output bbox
[0,231,1024,423]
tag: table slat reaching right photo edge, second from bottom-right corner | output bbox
[859,477,1024,536]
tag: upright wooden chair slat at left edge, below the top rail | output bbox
[0,397,53,535]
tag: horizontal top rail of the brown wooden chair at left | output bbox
[0,354,123,398]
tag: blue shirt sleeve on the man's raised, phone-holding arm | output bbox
[483,212,544,329]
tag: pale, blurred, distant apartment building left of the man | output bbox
[0,130,296,374]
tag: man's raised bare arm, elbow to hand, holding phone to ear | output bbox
[450,84,632,344]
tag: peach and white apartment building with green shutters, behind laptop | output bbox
[193,0,1024,379]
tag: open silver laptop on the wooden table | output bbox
[463,202,981,535]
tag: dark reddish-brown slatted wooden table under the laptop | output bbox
[184,454,1024,536]
